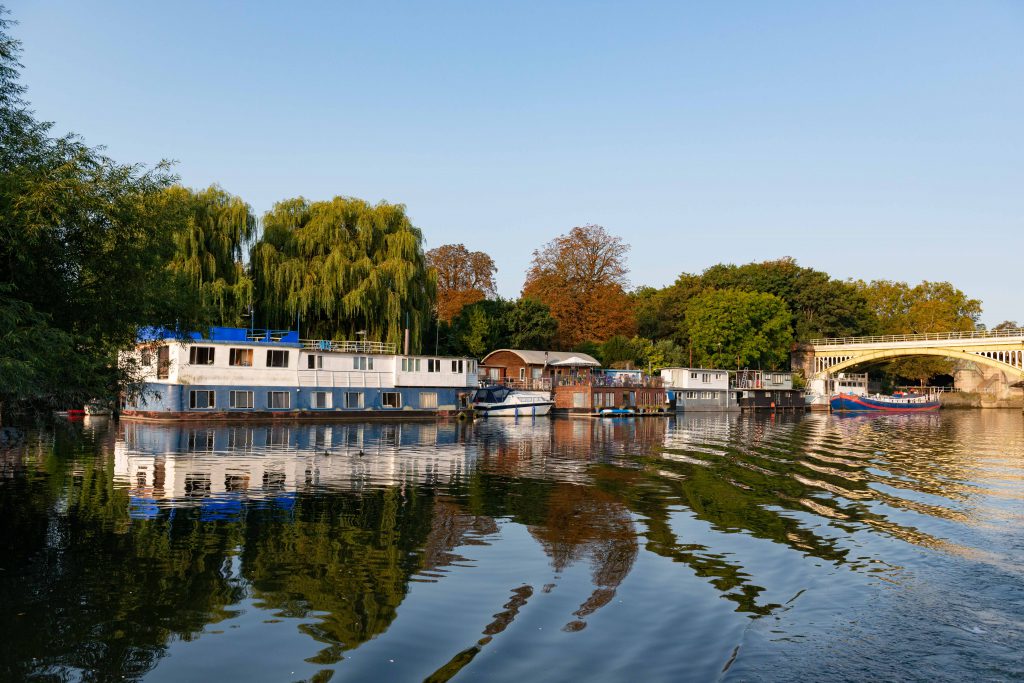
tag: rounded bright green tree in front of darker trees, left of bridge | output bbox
[686,290,793,370]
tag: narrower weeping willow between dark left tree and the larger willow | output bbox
[164,185,256,325]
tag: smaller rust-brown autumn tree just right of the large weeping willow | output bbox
[426,245,498,323]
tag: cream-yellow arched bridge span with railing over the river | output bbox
[795,328,1024,380]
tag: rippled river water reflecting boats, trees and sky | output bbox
[0,411,1024,682]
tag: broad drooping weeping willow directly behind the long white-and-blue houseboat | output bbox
[252,197,437,349]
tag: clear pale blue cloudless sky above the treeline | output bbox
[8,0,1024,325]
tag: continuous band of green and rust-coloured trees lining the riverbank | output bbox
[0,14,995,417]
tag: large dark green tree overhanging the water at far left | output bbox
[0,16,201,417]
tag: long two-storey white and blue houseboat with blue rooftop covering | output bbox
[122,328,477,420]
